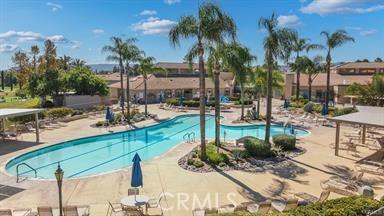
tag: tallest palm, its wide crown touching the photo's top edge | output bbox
[168,3,236,161]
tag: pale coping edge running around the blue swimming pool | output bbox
[0,114,311,182]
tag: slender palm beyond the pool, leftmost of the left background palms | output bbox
[102,37,125,115]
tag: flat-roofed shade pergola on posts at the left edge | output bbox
[0,109,44,143]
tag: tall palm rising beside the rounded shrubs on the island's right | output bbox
[259,14,288,143]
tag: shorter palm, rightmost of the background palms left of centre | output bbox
[137,55,166,116]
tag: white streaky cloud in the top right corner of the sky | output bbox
[300,0,384,16]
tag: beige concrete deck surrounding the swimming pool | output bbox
[0,101,384,215]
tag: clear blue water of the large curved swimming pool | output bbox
[6,115,308,179]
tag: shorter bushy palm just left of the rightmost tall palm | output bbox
[291,56,325,101]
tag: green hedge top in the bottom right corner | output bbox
[289,196,384,216]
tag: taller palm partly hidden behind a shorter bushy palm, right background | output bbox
[290,32,324,100]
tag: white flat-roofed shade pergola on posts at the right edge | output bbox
[328,106,384,156]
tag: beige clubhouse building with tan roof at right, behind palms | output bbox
[284,62,384,104]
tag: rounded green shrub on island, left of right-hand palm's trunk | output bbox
[244,138,273,157]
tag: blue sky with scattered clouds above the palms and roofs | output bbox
[0,0,384,69]
